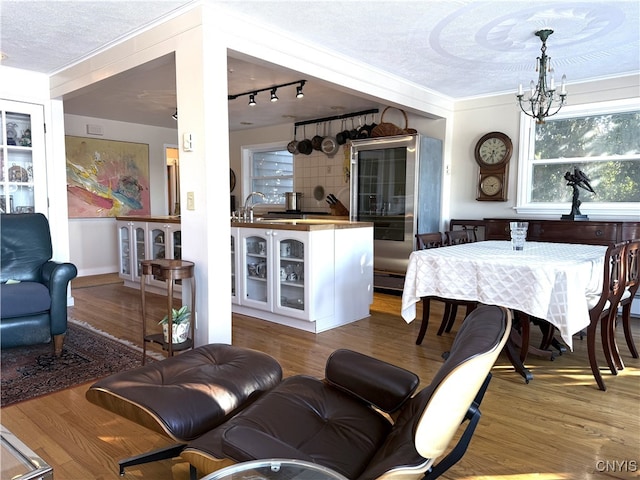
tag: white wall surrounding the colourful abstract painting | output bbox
[64,115,178,277]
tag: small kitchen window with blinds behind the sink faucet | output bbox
[244,147,293,205]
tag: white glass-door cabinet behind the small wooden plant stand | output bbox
[116,217,182,295]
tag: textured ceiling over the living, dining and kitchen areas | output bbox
[0,0,640,129]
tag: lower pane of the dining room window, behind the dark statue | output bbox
[531,159,640,203]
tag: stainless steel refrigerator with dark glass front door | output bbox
[350,134,442,275]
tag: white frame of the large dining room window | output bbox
[515,99,640,220]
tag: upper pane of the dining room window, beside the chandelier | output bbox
[534,112,640,160]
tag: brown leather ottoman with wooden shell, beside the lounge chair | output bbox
[86,344,282,475]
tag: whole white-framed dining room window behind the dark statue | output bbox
[517,102,640,215]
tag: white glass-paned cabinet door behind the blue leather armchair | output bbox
[0,100,47,213]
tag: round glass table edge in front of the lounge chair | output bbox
[202,458,347,480]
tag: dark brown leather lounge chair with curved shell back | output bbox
[181,306,511,480]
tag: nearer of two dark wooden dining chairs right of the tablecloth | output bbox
[587,242,626,391]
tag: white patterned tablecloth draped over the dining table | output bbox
[402,241,607,348]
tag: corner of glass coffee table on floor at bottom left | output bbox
[0,425,53,480]
